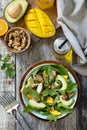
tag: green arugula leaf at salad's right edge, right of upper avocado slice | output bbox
[66,80,78,92]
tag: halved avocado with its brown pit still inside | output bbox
[4,0,28,23]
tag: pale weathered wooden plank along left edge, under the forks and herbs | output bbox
[0,0,15,130]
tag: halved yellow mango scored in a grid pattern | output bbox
[24,8,55,38]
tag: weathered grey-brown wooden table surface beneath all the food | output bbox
[0,0,87,130]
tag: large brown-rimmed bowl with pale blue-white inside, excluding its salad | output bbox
[19,60,80,120]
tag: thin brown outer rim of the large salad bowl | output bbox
[19,60,80,121]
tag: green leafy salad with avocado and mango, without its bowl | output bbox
[21,64,78,121]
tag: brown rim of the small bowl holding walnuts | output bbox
[4,26,31,53]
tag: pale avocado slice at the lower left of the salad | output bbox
[29,99,46,109]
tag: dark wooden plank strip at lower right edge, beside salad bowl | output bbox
[77,75,87,130]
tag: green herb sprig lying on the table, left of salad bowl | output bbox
[0,54,16,78]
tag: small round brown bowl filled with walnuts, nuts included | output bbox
[4,27,30,53]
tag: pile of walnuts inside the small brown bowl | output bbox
[8,30,27,51]
